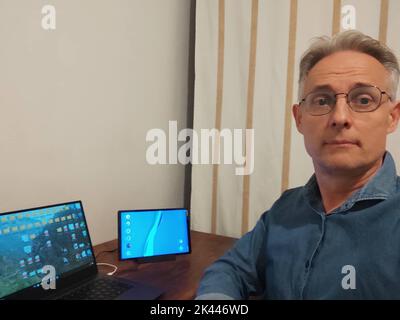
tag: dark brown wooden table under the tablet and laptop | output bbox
[94,231,237,300]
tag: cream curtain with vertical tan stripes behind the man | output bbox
[191,0,400,237]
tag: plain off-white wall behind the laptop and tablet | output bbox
[0,0,190,244]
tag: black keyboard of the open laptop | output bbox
[61,278,133,300]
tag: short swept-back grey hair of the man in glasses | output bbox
[298,30,400,100]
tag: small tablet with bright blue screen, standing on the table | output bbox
[118,209,191,260]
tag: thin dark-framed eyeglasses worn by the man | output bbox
[299,86,392,116]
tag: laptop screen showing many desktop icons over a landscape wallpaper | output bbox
[0,201,95,298]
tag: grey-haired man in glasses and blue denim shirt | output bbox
[197,31,400,299]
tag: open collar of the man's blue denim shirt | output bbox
[304,151,397,214]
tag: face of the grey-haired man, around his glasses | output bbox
[293,51,400,173]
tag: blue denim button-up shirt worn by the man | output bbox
[197,152,400,299]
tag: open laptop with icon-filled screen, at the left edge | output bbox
[0,201,163,300]
